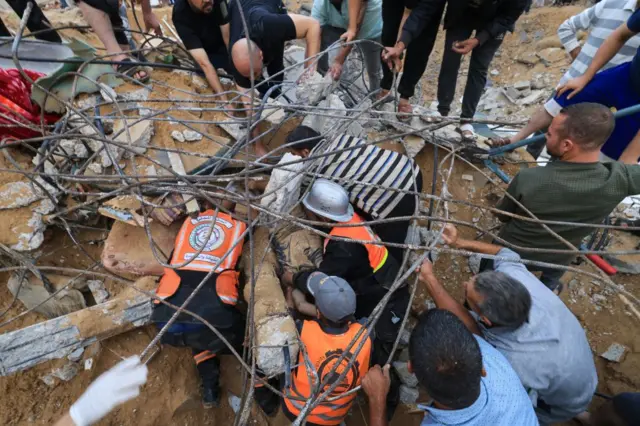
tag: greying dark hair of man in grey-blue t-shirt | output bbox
[473,271,531,328]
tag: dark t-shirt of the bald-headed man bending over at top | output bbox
[229,0,296,87]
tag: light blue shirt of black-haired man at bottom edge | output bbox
[419,336,538,426]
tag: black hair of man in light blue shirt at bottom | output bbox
[409,309,482,410]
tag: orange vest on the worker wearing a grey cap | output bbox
[284,321,371,425]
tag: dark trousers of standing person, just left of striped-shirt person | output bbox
[438,26,502,119]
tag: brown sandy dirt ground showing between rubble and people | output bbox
[0,6,640,426]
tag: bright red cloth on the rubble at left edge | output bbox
[0,68,60,143]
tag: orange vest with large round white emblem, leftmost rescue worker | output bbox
[156,210,247,305]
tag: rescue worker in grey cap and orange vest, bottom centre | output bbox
[282,272,372,426]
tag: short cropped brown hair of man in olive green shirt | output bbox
[560,102,616,151]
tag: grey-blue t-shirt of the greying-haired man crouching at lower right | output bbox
[479,248,598,424]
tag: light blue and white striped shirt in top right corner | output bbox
[558,0,640,85]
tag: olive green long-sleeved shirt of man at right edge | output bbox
[496,161,640,265]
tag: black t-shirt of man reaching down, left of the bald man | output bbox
[172,0,229,54]
